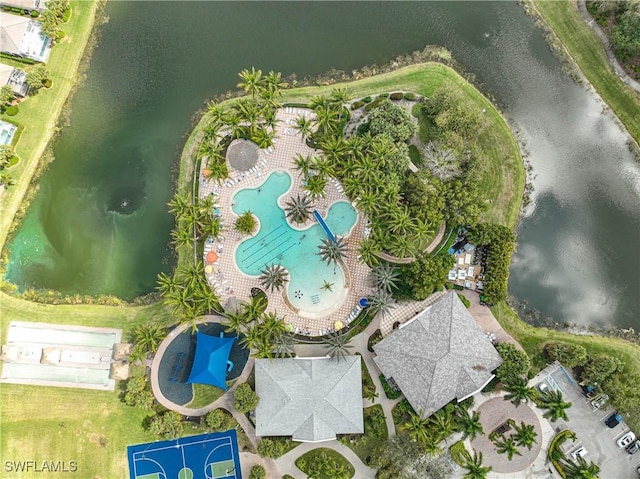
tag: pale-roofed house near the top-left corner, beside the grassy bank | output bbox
[0,12,51,62]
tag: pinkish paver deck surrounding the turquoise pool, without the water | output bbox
[199,107,374,336]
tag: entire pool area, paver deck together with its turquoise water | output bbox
[199,107,374,336]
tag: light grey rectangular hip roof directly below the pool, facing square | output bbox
[255,356,364,442]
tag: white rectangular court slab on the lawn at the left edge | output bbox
[0,321,122,391]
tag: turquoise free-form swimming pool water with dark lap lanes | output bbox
[233,171,357,316]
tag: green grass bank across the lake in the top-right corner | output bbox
[533,0,640,143]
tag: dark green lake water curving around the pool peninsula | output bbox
[7,1,640,328]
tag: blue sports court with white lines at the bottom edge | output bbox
[127,430,242,479]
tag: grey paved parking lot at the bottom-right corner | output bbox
[530,365,640,479]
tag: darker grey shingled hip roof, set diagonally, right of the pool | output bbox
[373,292,502,417]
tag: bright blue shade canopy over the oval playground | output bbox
[187,331,236,390]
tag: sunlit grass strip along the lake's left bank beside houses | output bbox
[0,1,98,253]
